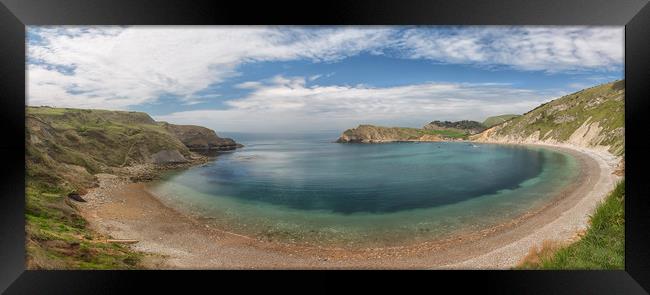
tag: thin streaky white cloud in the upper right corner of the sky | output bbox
[399,27,624,72]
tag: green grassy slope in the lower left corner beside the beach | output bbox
[25,181,144,269]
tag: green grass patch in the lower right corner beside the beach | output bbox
[518,182,625,269]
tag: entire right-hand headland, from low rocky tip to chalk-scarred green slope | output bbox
[337,80,625,163]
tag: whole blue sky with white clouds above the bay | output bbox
[26,26,624,133]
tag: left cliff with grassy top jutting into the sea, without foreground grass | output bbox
[25,107,240,188]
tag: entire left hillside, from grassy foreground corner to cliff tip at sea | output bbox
[25,107,237,269]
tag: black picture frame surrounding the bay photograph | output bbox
[0,0,650,294]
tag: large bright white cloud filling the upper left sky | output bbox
[28,26,388,108]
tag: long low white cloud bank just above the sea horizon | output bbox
[156,77,560,132]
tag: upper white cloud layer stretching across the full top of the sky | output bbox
[28,26,623,109]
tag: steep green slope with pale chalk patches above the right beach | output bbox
[470,80,625,156]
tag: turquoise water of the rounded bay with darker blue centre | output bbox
[149,135,577,246]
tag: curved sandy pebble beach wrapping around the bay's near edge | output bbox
[80,145,621,269]
